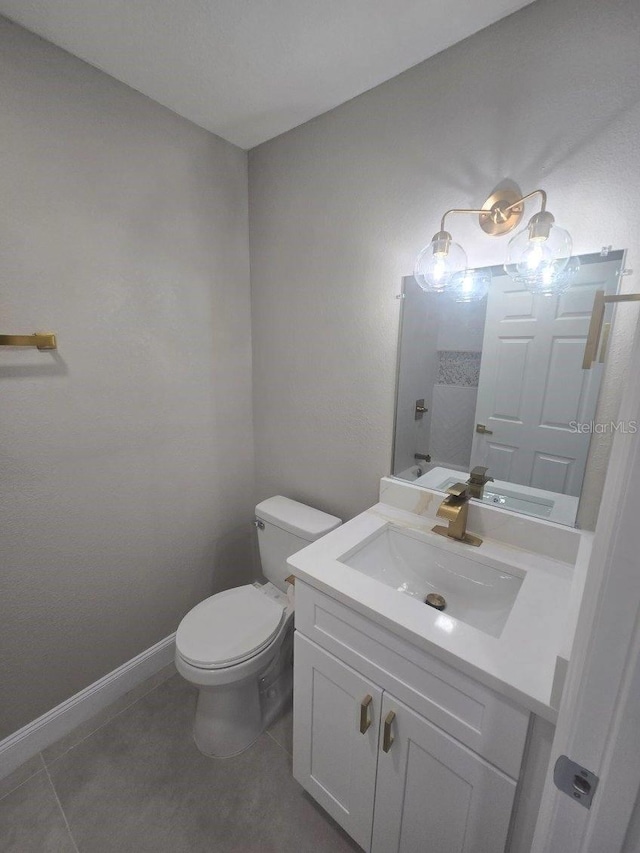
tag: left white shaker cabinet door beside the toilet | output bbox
[293,631,382,850]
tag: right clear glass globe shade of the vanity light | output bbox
[504,211,572,295]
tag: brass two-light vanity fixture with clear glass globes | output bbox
[413,189,575,295]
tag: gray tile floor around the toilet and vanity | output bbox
[0,670,360,853]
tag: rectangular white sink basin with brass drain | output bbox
[340,525,524,637]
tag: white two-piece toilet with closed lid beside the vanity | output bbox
[176,496,341,757]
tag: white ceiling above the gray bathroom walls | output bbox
[0,0,531,148]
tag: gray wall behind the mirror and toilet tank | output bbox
[249,0,640,517]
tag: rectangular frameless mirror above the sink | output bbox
[392,251,624,526]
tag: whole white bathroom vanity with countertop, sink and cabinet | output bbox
[289,478,591,853]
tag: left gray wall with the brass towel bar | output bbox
[0,20,253,738]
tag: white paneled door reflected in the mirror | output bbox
[471,261,619,497]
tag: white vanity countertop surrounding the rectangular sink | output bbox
[288,503,575,722]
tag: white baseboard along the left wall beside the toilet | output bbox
[0,634,176,779]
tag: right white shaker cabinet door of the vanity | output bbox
[371,693,516,853]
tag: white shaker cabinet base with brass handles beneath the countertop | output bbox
[293,582,529,853]
